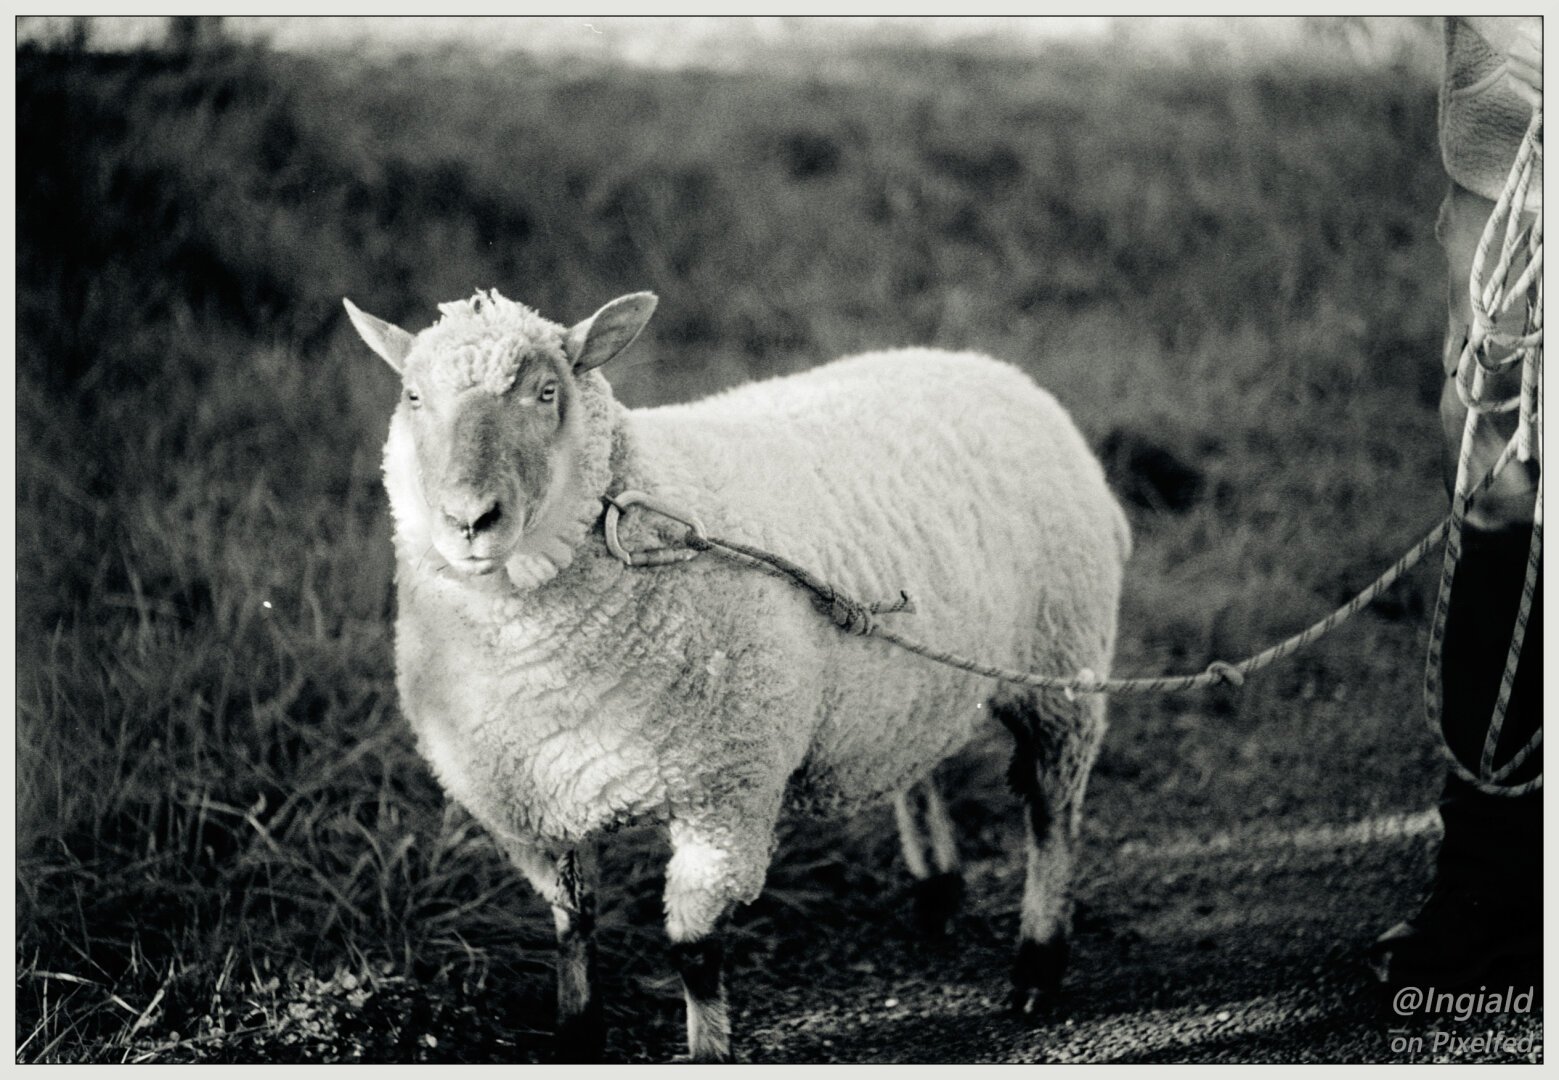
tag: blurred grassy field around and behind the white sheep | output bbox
[16,20,1515,1061]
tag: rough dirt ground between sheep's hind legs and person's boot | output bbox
[723,814,1542,1063]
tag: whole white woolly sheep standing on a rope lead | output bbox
[346,290,1130,1061]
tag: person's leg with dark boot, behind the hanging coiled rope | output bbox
[1370,189,1542,988]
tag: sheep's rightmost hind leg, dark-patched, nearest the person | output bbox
[996,695,1104,1016]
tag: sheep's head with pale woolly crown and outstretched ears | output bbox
[346,290,655,588]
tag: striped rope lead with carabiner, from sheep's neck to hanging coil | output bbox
[602,111,1542,796]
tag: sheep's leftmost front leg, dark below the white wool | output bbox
[508,846,603,1061]
